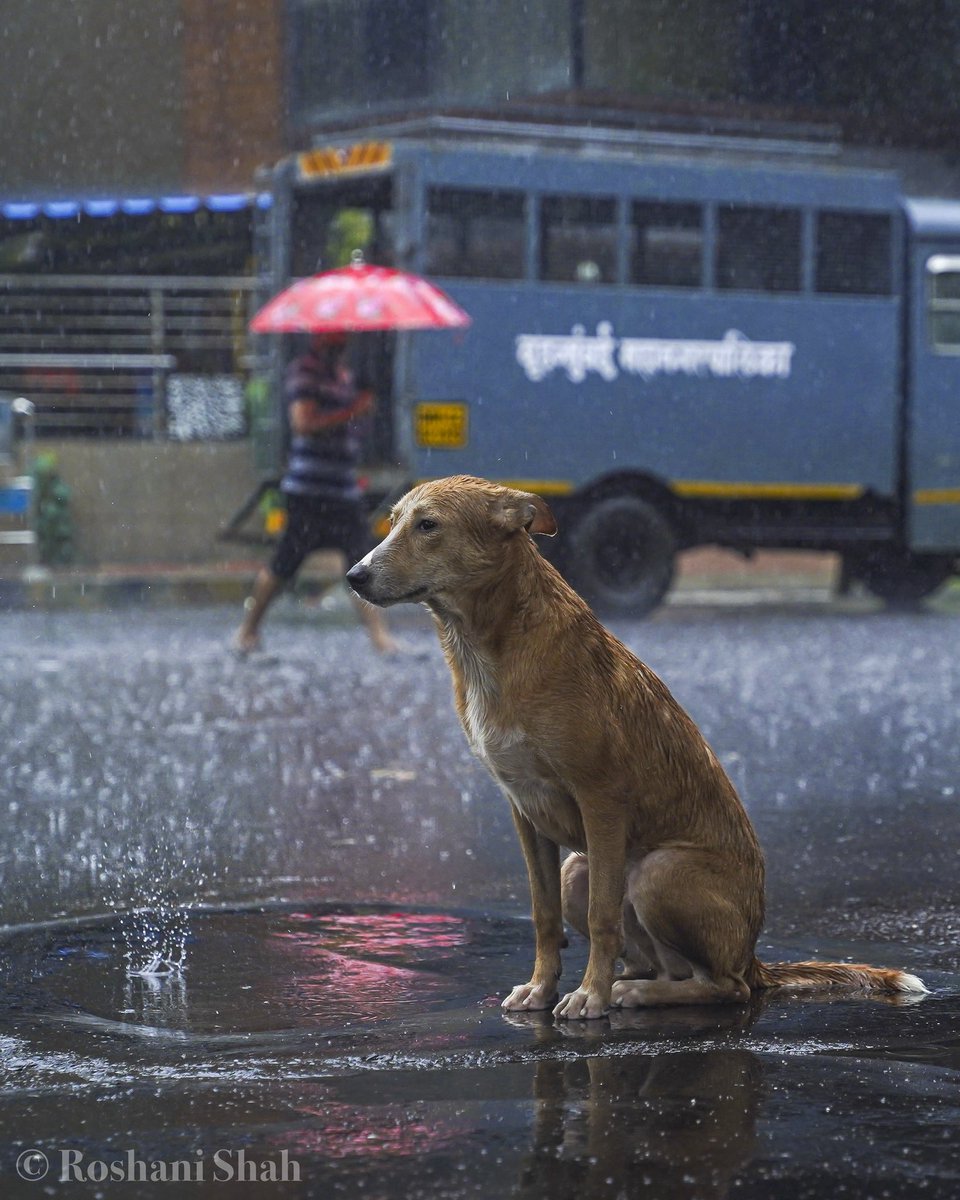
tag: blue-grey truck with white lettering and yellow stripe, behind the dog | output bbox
[253,118,960,614]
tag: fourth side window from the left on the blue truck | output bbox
[716,204,802,292]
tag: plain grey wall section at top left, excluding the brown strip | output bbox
[0,0,184,198]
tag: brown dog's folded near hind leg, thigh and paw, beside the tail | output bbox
[612,850,761,1008]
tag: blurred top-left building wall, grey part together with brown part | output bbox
[0,0,284,199]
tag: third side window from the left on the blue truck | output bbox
[630,200,703,288]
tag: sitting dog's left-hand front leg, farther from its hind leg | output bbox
[502,803,565,1012]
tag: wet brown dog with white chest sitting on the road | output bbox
[347,476,926,1018]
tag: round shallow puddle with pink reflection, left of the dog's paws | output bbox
[0,905,529,1046]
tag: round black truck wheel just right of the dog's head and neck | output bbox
[564,496,677,617]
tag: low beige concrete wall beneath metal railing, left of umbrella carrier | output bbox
[45,439,258,566]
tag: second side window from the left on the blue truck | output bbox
[540,196,617,283]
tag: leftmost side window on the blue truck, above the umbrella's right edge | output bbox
[425,187,526,280]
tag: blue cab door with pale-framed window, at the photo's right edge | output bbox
[906,244,960,554]
